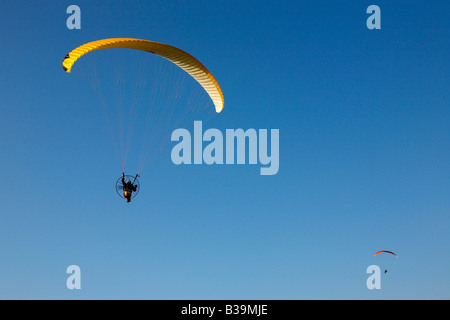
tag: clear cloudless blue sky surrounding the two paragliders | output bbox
[0,0,450,299]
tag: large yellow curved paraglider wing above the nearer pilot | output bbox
[62,38,224,113]
